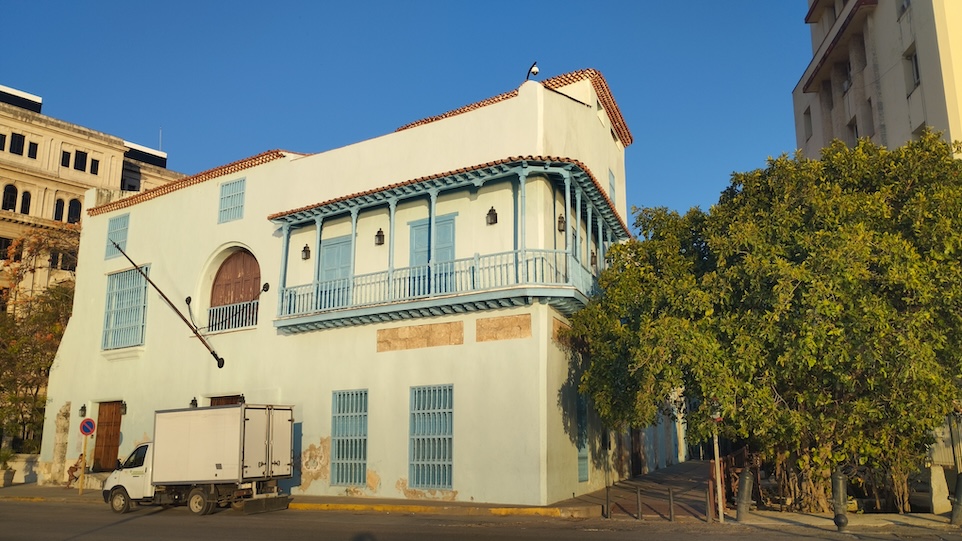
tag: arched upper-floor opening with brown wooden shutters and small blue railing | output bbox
[207,250,261,331]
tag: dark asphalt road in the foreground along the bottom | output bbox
[0,502,962,541]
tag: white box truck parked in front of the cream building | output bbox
[103,404,294,515]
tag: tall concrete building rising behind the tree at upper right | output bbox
[792,0,962,157]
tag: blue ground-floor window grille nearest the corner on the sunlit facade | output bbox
[409,385,454,489]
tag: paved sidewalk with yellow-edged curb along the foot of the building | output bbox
[0,460,962,532]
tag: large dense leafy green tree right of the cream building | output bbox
[568,133,962,511]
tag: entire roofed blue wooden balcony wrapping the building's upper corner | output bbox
[271,159,629,333]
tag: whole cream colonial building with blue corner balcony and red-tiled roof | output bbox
[35,70,685,504]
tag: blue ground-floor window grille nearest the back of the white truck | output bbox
[331,389,367,486]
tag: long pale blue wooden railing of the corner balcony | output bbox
[279,250,595,317]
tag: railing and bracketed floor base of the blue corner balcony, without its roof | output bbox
[274,250,597,333]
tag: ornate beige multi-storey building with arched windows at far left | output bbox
[0,86,183,304]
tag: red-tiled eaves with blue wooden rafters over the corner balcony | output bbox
[268,156,631,241]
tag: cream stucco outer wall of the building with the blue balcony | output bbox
[41,74,652,504]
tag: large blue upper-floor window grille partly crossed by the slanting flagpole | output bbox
[102,267,149,349]
